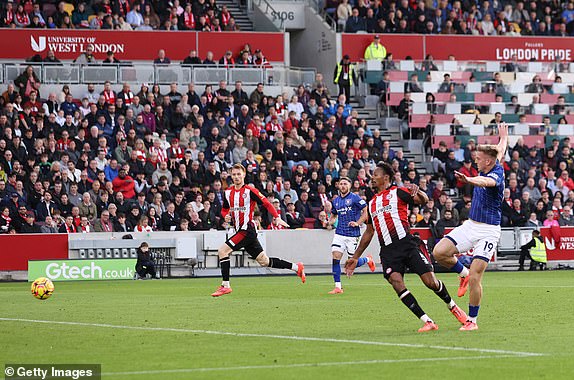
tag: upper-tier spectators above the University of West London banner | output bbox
[0,0,239,32]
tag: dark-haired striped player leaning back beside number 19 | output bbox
[345,162,466,332]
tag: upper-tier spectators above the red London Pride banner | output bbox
[325,0,574,36]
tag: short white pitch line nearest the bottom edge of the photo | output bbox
[102,355,521,376]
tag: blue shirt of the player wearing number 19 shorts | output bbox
[469,160,504,226]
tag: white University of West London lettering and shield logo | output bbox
[30,36,125,54]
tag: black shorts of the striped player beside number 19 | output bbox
[380,235,433,280]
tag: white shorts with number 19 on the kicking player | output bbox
[445,219,500,262]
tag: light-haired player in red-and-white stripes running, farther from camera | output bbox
[212,164,305,297]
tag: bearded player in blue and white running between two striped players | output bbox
[329,177,375,294]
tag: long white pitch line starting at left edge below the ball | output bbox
[0,318,544,356]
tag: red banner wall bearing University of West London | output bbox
[0,29,289,62]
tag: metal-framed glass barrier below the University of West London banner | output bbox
[0,62,317,86]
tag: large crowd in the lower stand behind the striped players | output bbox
[0,67,414,233]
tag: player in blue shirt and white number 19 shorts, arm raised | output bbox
[433,123,508,331]
